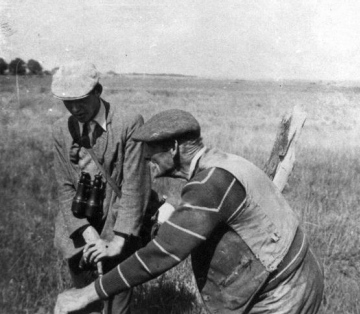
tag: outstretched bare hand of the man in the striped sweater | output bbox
[54,283,100,314]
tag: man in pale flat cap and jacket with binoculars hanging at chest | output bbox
[51,63,150,314]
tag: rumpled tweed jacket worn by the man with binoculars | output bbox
[53,100,150,258]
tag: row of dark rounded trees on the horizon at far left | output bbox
[0,58,52,75]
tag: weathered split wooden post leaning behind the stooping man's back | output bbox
[264,106,306,191]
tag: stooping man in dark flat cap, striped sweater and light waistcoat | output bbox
[55,110,324,314]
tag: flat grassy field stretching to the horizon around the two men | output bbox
[0,75,360,314]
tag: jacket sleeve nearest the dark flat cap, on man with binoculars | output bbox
[113,115,150,236]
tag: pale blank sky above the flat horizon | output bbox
[0,0,360,80]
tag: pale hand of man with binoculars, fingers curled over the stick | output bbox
[83,235,125,263]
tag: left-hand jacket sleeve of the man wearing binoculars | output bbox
[53,126,89,238]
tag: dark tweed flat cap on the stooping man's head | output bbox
[132,109,201,142]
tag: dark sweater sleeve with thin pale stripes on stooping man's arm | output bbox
[95,168,246,299]
